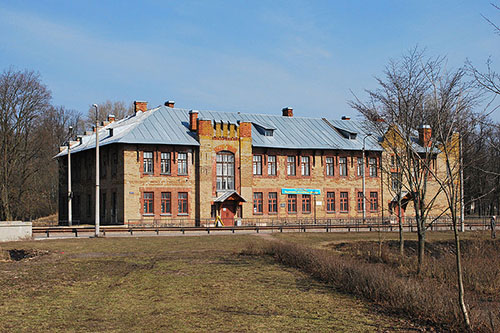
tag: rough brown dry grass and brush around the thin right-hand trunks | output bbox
[257,232,500,331]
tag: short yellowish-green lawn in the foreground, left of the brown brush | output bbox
[0,235,411,332]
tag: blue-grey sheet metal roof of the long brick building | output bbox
[56,106,394,157]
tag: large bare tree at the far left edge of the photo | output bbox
[0,69,51,220]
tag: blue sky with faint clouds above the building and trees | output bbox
[0,0,500,120]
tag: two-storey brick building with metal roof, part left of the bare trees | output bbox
[57,101,452,225]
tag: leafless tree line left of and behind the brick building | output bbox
[0,68,132,221]
